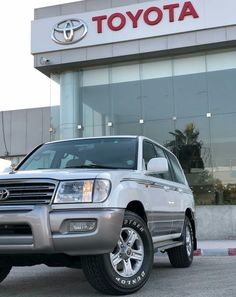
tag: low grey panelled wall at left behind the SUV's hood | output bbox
[0,107,50,159]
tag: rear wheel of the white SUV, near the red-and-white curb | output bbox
[167,217,194,268]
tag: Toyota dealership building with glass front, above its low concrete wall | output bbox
[0,0,236,208]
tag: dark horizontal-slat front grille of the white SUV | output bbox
[0,180,56,205]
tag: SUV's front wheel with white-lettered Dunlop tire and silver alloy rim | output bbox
[82,211,153,295]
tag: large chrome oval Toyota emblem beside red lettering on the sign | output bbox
[51,18,88,44]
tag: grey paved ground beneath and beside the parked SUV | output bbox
[0,257,236,297]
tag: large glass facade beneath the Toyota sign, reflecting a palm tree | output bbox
[51,50,236,204]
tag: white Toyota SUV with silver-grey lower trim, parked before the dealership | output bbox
[0,136,197,295]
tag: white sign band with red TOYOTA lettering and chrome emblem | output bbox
[32,0,236,54]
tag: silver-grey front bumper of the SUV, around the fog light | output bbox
[0,205,124,255]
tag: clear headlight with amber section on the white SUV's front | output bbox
[54,179,110,203]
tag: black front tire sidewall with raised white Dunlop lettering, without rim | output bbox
[101,213,153,292]
